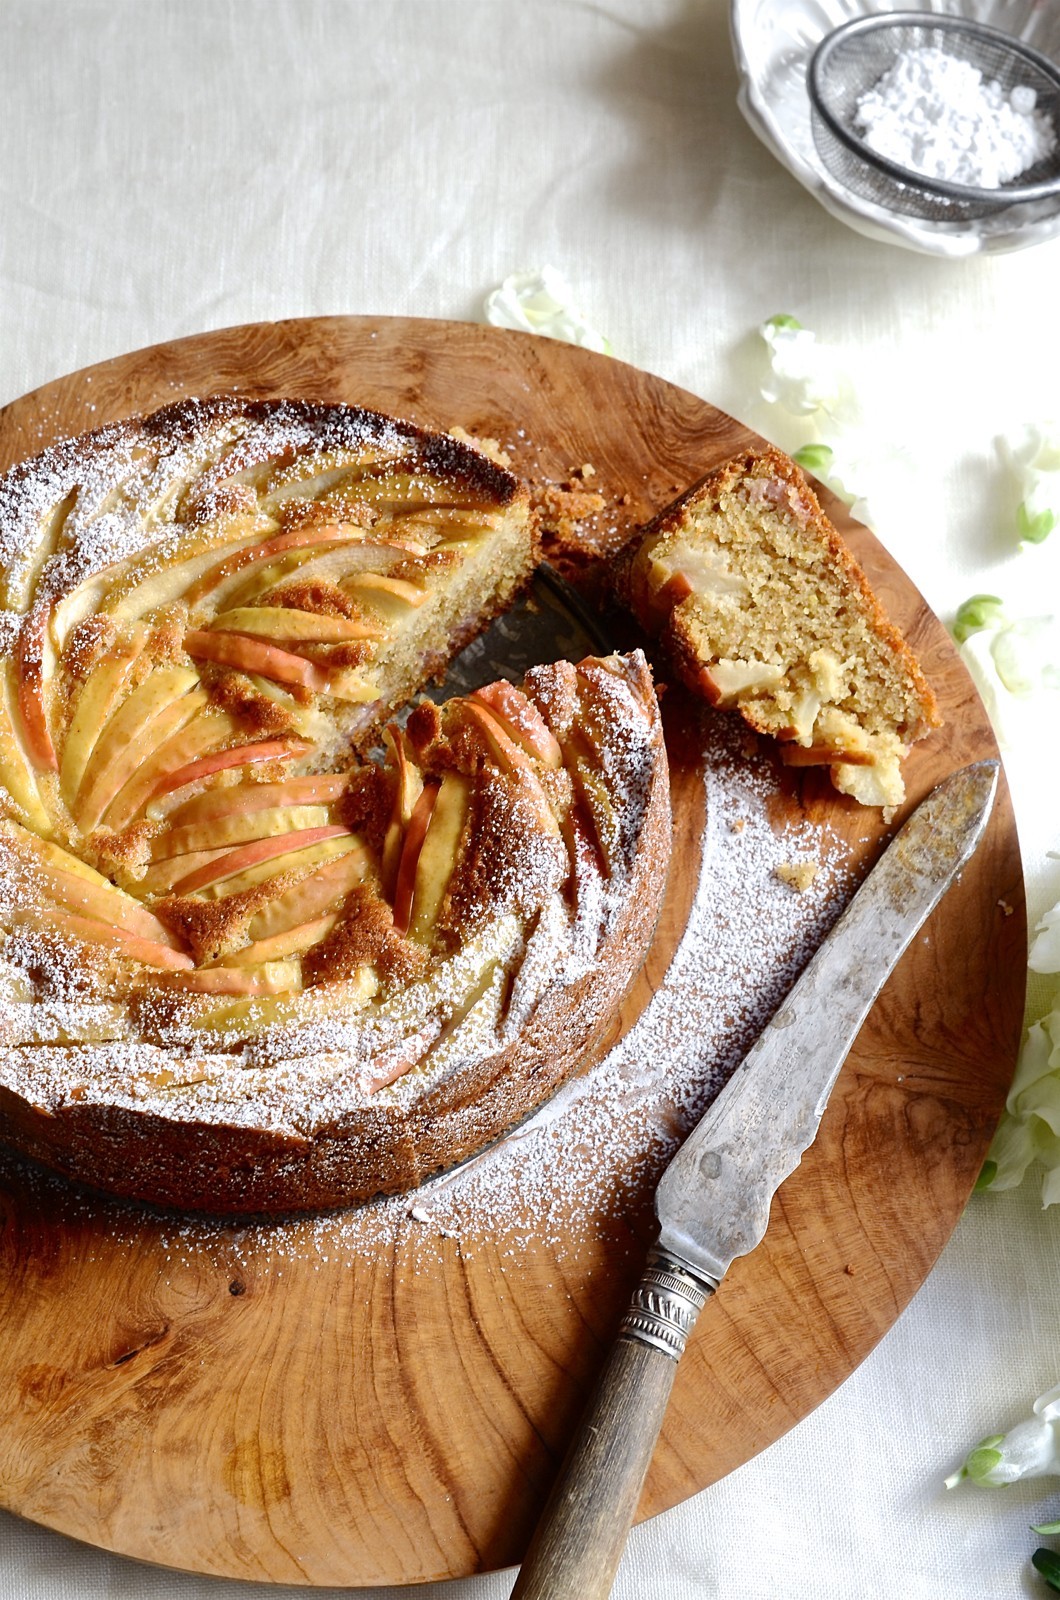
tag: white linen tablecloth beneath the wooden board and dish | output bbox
[0,0,1060,1600]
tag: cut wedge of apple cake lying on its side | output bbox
[615,450,940,808]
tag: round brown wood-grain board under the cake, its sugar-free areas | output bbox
[0,317,1025,1587]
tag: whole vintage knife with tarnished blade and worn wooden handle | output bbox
[512,762,999,1600]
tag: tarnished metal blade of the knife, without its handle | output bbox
[655,762,999,1288]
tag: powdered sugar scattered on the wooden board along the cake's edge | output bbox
[0,717,852,1272]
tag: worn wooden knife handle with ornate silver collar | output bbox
[512,1250,717,1600]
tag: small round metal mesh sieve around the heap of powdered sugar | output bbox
[807,11,1060,222]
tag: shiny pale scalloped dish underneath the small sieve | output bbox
[730,0,1060,256]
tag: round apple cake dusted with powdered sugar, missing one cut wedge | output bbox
[0,400,669,1213]
